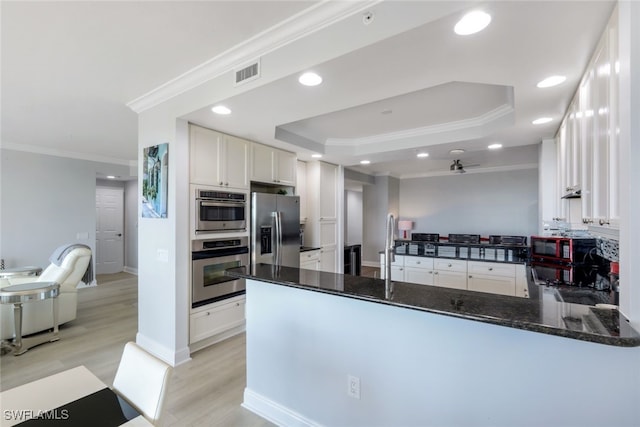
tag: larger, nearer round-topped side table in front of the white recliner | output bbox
[0,282,60,356]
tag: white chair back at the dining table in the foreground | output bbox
[113,342,172,425]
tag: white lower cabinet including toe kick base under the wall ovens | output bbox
[189,295,246,350]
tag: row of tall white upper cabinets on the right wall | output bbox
[556,13,619,228]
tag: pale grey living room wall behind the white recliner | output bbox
[0,149,129,268]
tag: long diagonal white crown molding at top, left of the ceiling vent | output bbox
[127,0,383,113]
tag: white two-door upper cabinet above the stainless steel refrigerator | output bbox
[251,143,297,186]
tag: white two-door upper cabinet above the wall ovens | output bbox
[189,125,250,189]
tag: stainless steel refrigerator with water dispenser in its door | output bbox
[251,192,300,271]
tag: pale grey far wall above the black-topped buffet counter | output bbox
[400,169,538,241]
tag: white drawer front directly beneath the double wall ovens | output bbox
[189,298,245,343]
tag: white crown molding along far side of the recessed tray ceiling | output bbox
[325,104,515,147]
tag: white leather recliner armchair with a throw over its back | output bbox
[0,247,92,340]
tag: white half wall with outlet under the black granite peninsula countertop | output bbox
[244,281,640,427]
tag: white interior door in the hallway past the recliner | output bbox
[96,187,124,274]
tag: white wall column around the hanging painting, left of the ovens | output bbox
[136,113,191,365]
